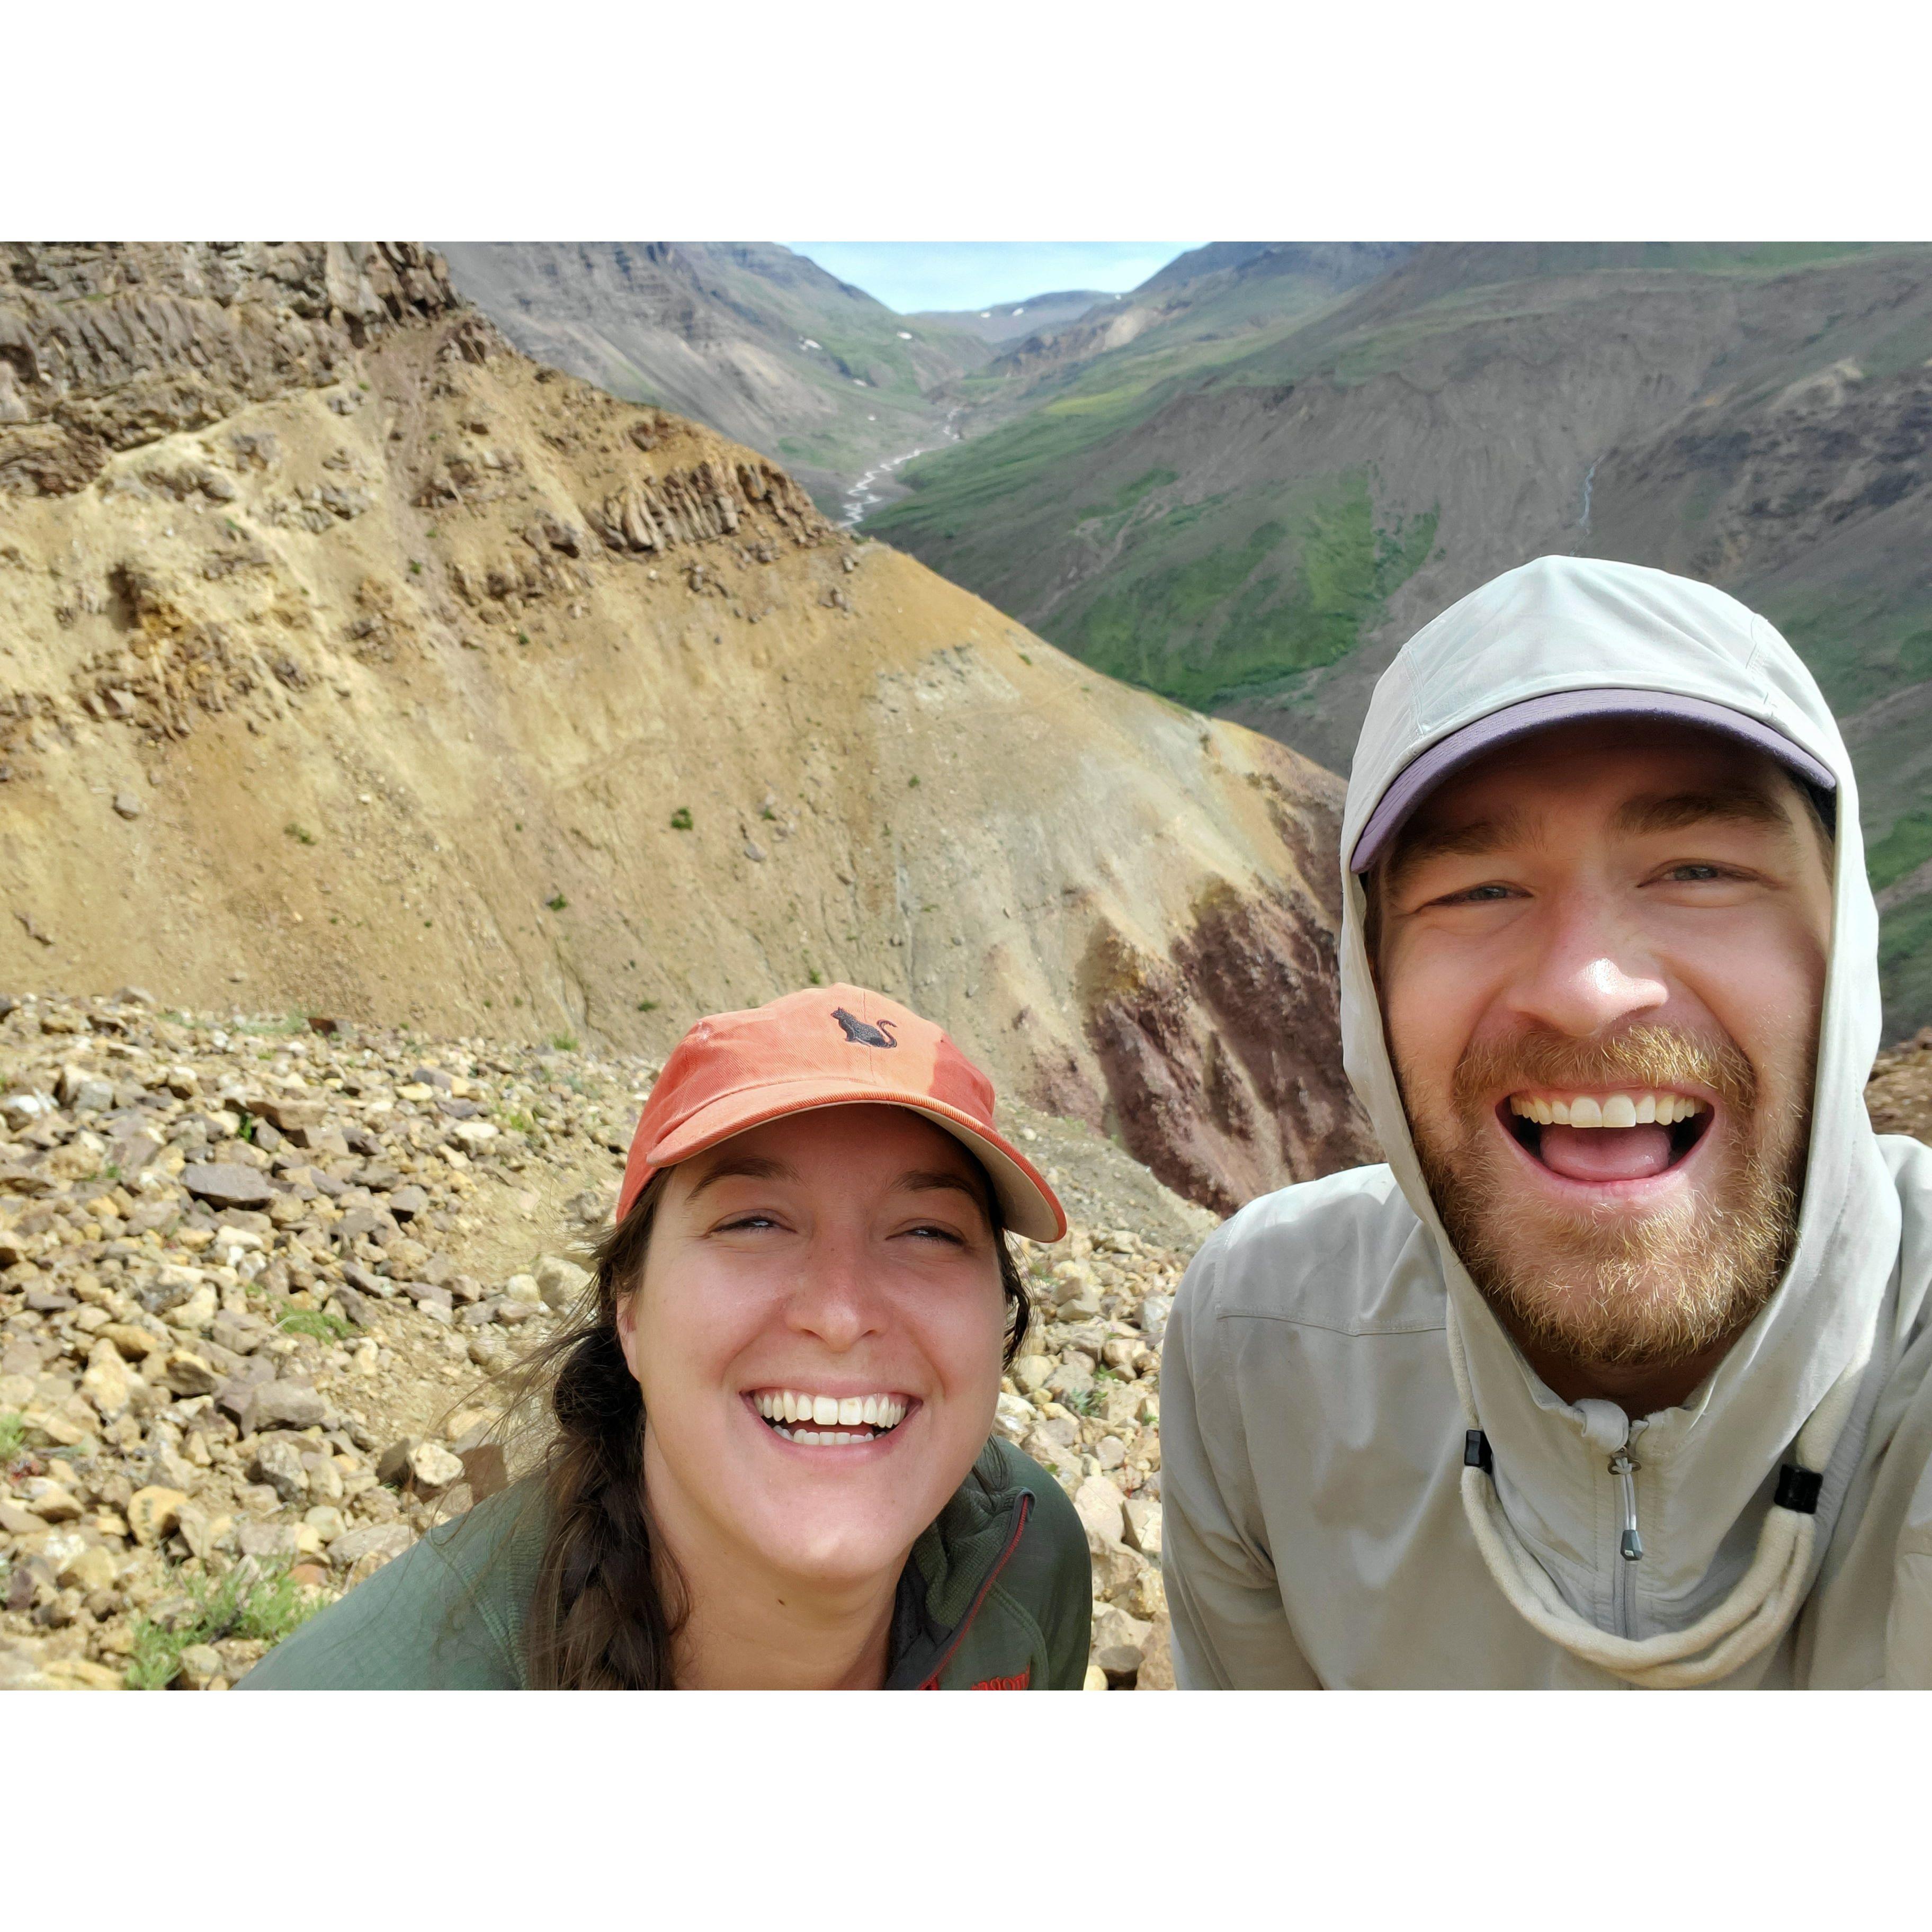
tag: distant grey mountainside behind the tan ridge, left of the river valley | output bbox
[442,241,993,514]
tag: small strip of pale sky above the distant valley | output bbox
[784,241,1200,315]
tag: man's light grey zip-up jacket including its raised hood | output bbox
[1161,558,1932,1688]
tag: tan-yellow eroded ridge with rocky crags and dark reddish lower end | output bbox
[0,244,1366,1210]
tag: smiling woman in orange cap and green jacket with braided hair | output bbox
[234,985,1092,1688]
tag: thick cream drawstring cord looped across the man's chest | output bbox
[1447,1300,1872,1690]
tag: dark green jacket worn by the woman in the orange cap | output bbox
[236,1437,1094,1690]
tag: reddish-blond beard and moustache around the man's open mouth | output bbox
[1397,1026,1812,1368]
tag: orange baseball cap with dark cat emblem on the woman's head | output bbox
[616,985,1067,1240]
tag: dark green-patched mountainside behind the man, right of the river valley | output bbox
[865,244,1932,1035]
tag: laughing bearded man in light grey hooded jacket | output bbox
[1161,558,1932,1688]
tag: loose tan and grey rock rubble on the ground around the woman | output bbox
[0,989,1213,1690]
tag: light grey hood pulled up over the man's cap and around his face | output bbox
[1341,557,1901,1636]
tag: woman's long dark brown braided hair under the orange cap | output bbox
[510,1150,1032,1690]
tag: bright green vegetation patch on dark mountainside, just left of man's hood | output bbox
[1055,469,1437,711]
